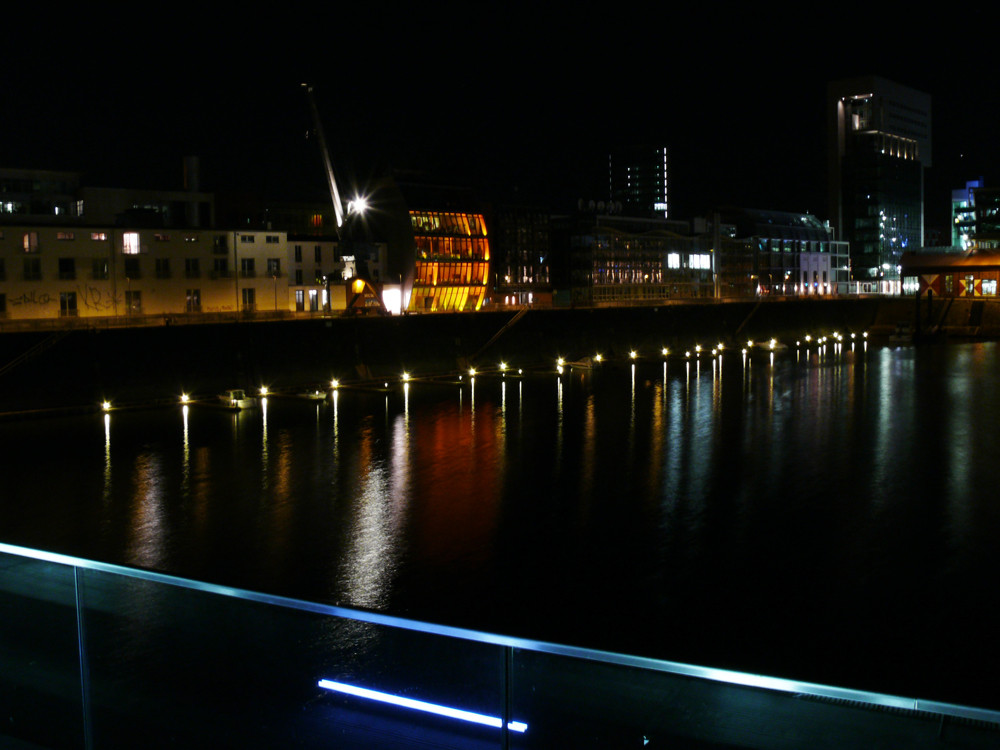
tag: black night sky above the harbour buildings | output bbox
[0,13,1000,238]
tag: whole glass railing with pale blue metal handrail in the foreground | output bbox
[0,544,1000,748]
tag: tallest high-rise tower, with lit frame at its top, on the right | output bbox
[828,76,931,292]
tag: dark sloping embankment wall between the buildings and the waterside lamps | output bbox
[0,297,1000,413]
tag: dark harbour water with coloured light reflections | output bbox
[0,343,1000,708]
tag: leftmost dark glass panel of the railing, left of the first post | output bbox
[0,554,84,748]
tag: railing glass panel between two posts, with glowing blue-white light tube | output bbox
[84,570,503,748]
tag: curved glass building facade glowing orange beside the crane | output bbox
[409,211,490,312]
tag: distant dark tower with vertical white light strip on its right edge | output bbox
[608,145,670,219]
